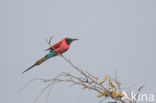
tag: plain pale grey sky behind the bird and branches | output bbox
[0,0,156,103]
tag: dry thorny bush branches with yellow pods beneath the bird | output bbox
[21,37,143,103]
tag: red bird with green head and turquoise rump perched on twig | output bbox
[23,38,78,73]
